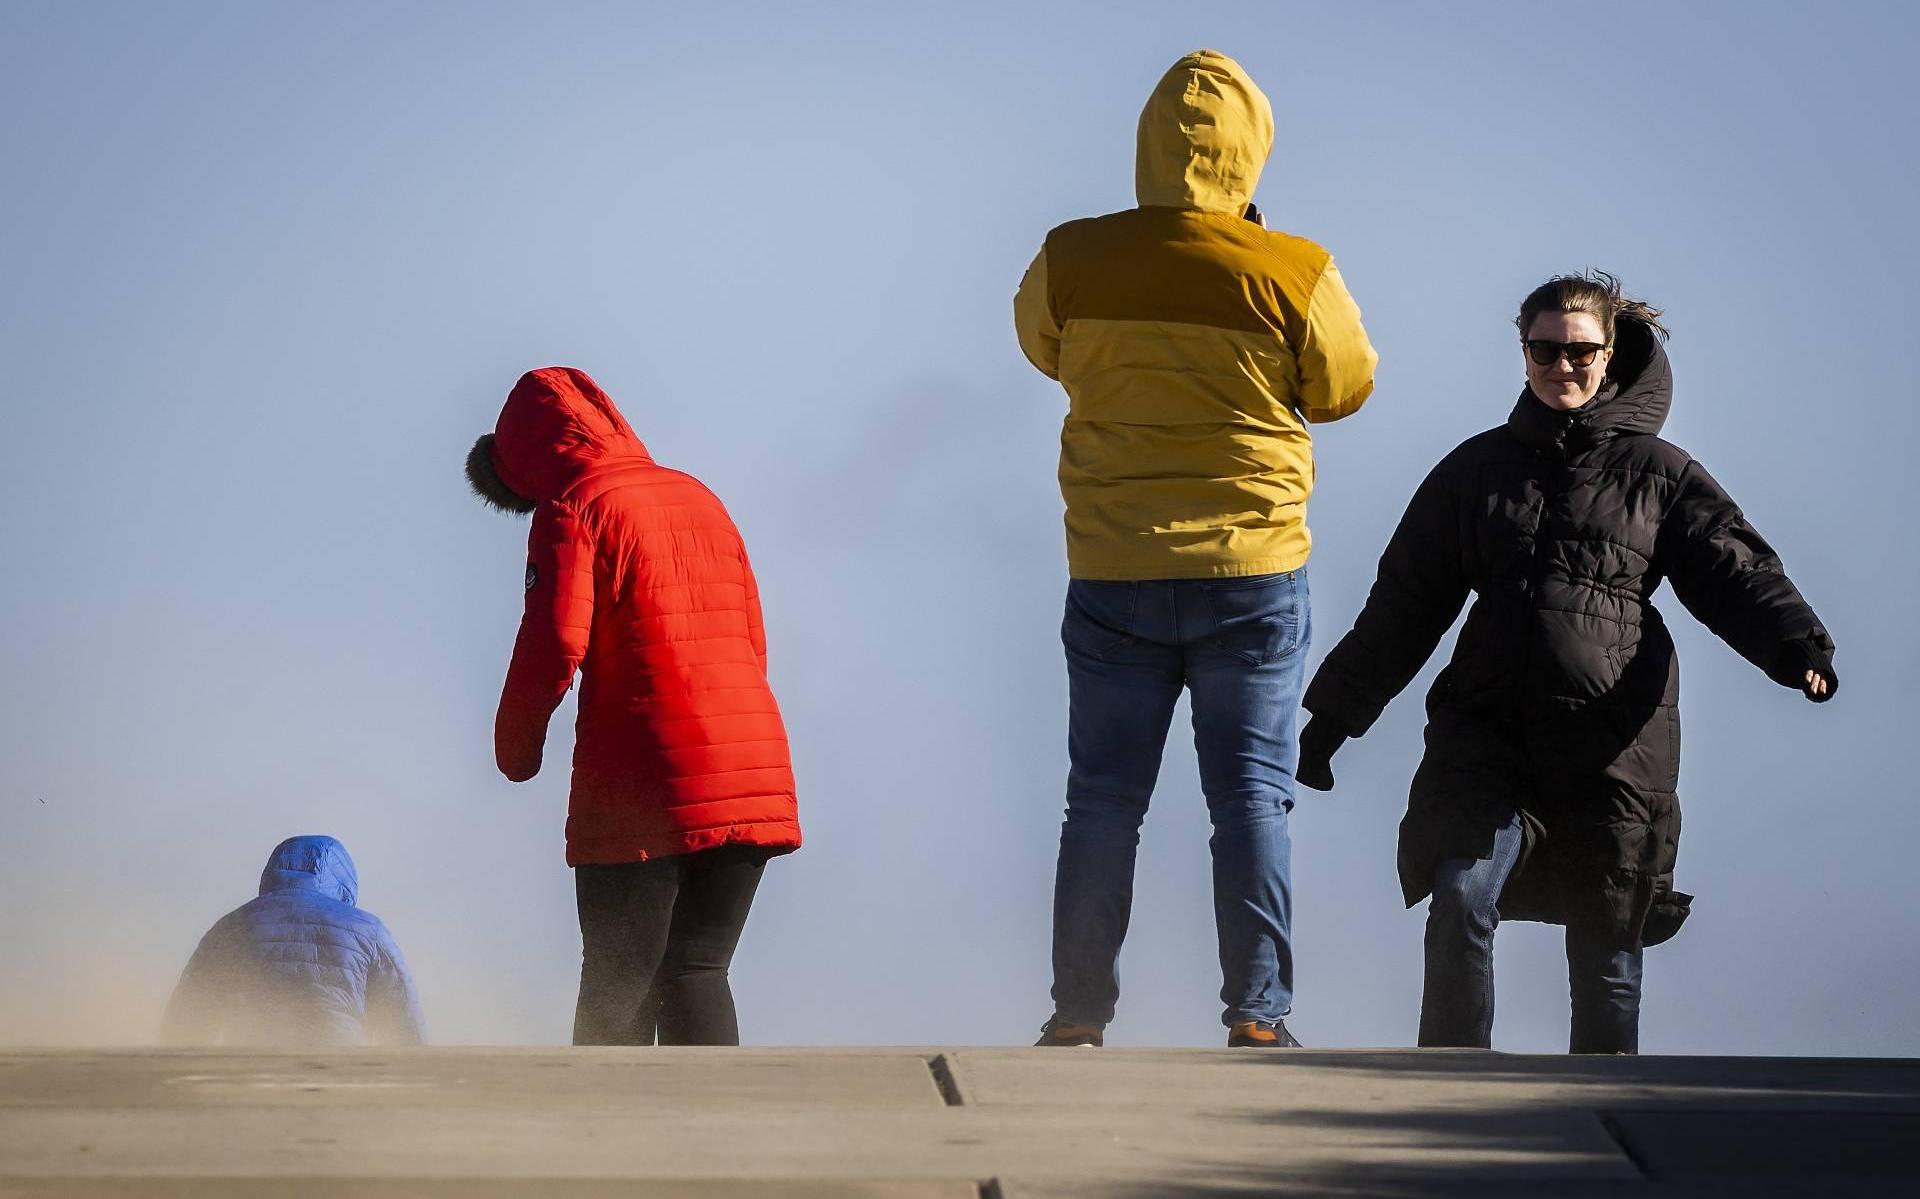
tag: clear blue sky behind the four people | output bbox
[0,0,1920,1055]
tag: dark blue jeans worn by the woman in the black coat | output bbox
[1421,815,1642,1053]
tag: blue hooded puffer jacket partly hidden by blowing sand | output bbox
[163,836,426,1047]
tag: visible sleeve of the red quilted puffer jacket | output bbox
[493,503,593,782]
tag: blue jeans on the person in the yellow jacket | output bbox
[1054,571,1309,1026]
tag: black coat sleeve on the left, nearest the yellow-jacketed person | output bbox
[1302,461,1469,736]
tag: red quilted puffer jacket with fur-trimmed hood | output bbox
[468,367,801,865]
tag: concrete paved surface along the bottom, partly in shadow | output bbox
[0,1049,1920,1199]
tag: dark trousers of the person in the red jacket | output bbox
[574,845,768,1045]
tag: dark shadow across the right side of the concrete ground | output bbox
[1100,1051,1920,1199]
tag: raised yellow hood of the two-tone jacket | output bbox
[1133,50,1273,215]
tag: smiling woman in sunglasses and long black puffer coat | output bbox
[1298,273,1839,1053]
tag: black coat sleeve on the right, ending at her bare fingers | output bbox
[1655,461,1834,674]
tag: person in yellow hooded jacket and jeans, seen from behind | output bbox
[1014,50,1379,1047]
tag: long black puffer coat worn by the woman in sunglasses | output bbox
[1306,319,1832,945]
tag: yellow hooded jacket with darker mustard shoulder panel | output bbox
[1014,50,1379,580]
